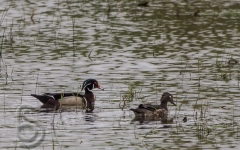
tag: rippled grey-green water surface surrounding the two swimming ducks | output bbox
[0,0,240,149]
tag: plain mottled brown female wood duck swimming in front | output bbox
[130,92,176,117]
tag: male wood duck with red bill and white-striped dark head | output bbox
[31,79,104,112]
